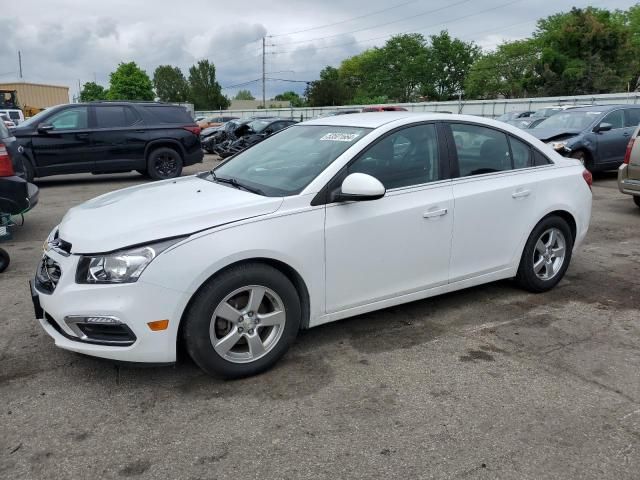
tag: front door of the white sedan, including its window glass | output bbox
[325,124,453,313]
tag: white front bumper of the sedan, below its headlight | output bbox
[31,250,188,363]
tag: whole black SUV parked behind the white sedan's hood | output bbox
[12,102,203,180]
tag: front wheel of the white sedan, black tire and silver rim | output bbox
[183,263,302,378]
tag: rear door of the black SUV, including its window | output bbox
[91,105,148,172]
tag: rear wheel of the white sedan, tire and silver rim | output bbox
[515,215,573,293]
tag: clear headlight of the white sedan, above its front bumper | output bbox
[76,238,182,283]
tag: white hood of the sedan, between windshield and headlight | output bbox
[59,176,282,253]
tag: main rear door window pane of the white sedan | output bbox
[451,123,511,177]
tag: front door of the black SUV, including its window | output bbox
[31,105,93,175]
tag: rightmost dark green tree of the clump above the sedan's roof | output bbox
[422,30,481,100]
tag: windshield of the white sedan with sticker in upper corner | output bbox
[207,125,371,197]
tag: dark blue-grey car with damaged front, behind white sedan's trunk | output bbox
[527,105,640,172]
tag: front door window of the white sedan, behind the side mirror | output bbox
[348,124,440,189]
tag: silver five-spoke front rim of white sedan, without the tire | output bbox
[209,285,286,363]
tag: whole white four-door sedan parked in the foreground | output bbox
[32,112,591,377]
